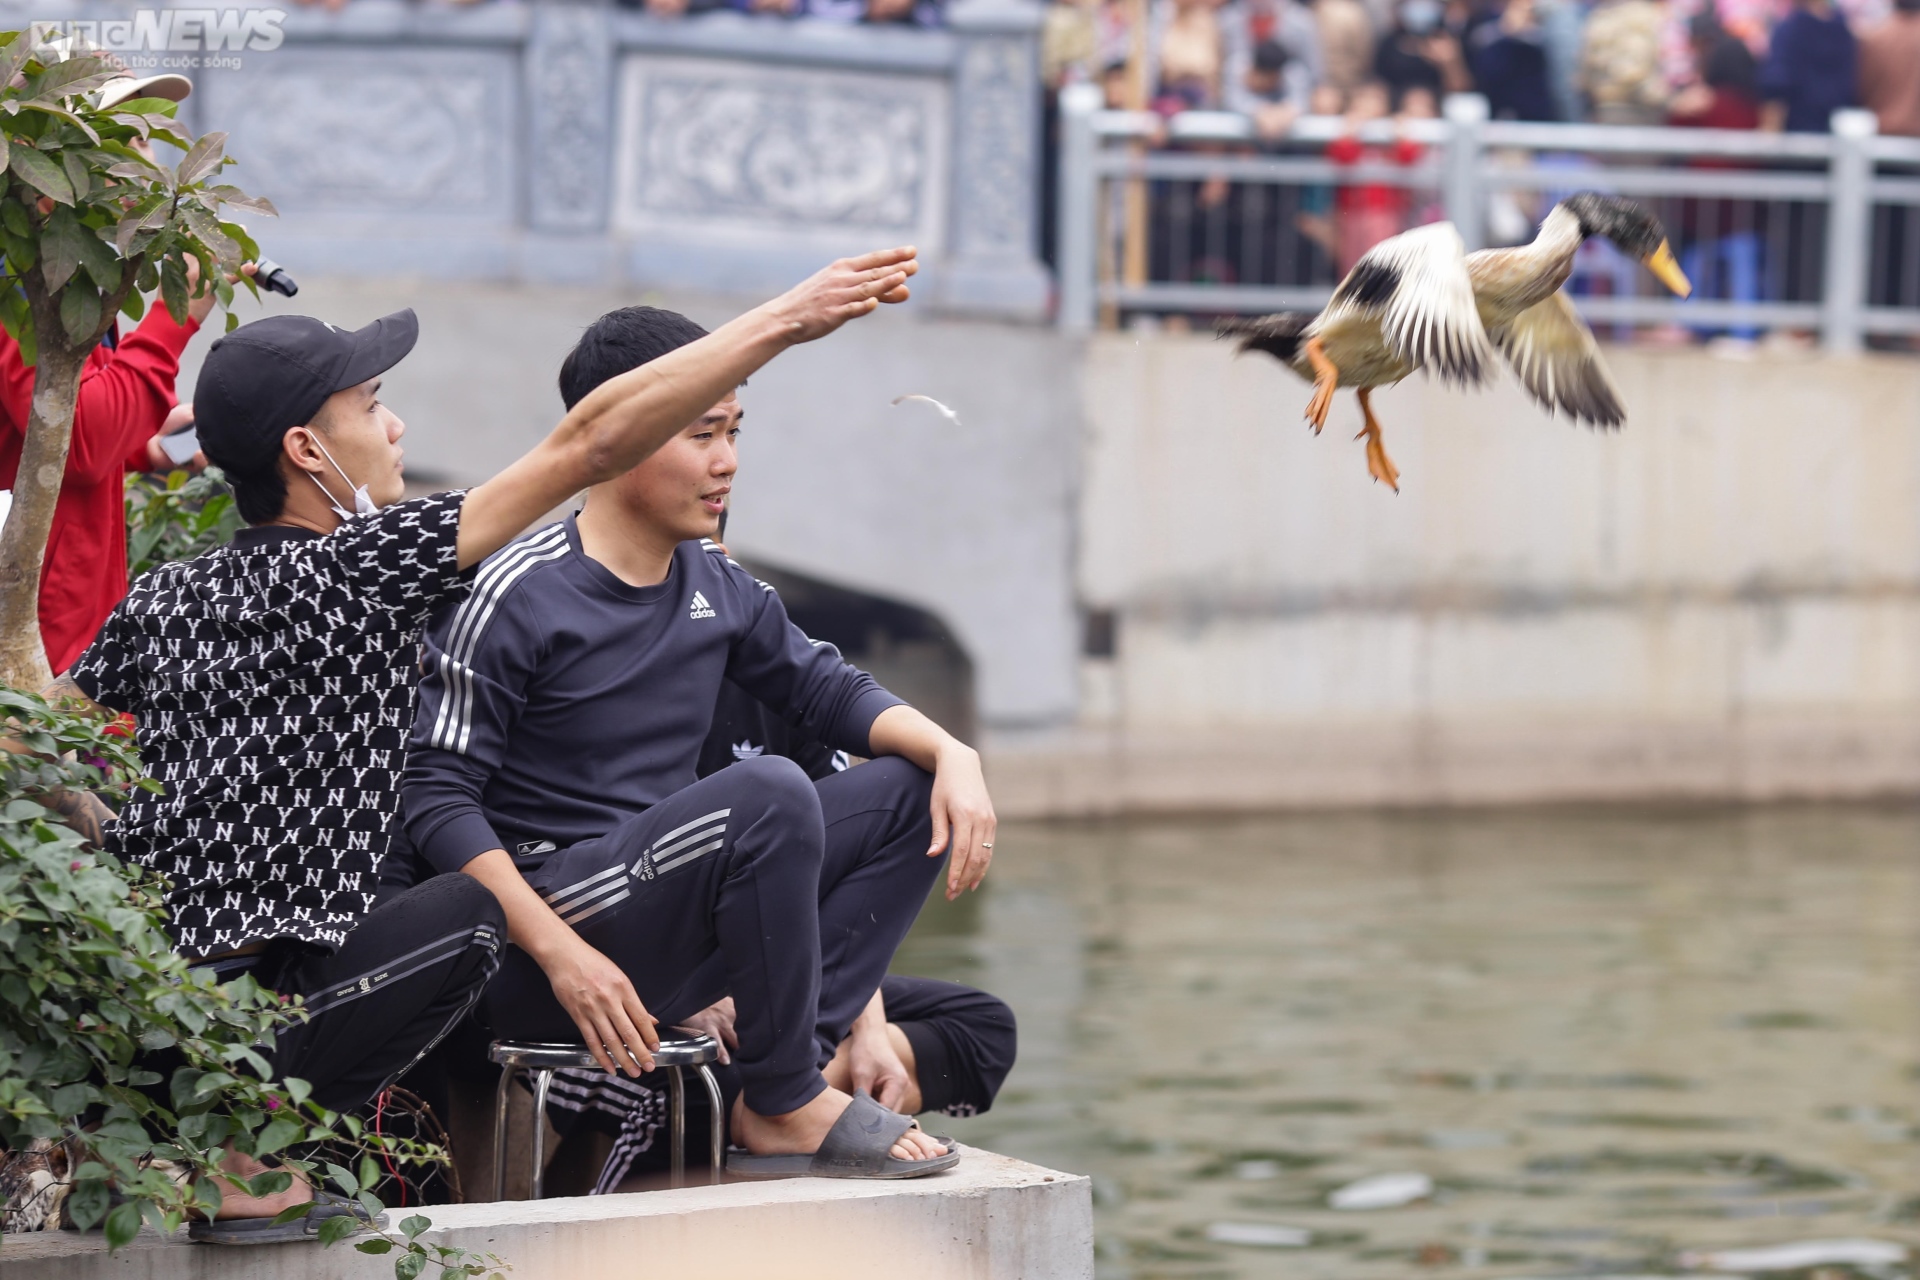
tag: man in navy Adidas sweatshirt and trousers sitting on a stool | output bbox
[403,307,995,1176]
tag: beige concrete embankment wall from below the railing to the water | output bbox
[996,334,1920,812]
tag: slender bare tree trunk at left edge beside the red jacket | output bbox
[0,335,86,693]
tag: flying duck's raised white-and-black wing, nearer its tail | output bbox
[1327,223,1494,386]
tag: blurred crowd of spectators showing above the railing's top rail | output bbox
[1043,0,1920,138]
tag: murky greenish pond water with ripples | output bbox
[897,808,1920,1280]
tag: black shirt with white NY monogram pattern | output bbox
[69,491,465,956]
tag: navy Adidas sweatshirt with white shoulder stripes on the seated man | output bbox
[403,520,900,871]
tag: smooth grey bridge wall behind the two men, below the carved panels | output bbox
[180,276,1079,727]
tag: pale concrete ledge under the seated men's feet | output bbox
[0,1150,1092,1280]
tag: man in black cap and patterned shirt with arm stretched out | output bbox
[54,248,916,1244]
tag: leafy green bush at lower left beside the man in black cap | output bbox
[0,687,499,1280]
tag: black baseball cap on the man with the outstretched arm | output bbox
[194,307,420,474]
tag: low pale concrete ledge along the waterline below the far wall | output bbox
[985,708,1920,818]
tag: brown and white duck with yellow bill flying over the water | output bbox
[1219,192,1693,493]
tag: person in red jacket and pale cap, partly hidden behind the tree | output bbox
[0,73,213,676]
